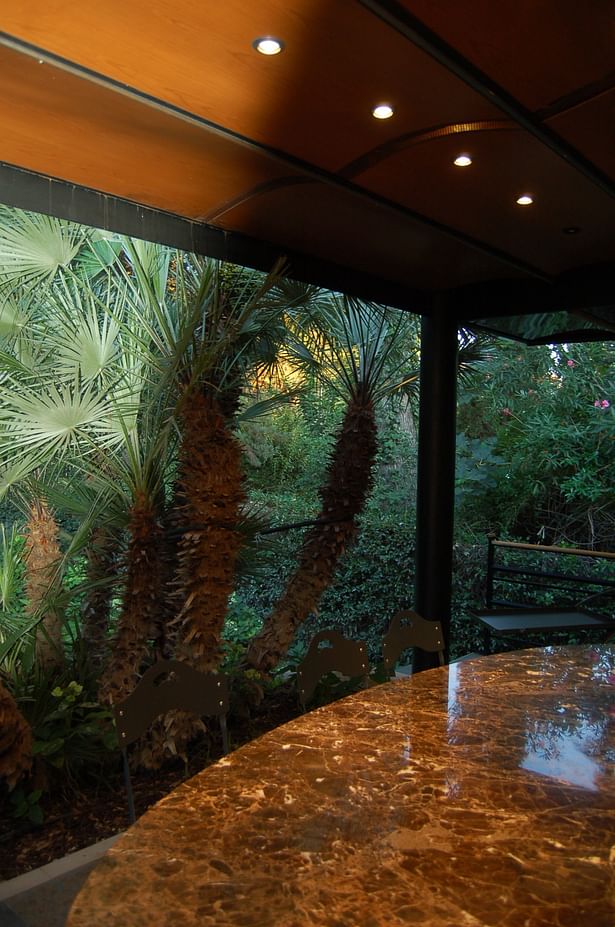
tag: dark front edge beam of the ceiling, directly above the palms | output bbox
[0,162,432,313]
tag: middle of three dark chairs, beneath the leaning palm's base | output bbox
[297,630,369,709]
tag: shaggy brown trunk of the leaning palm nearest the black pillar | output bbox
[247,399,376,672]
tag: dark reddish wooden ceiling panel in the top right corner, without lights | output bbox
[401,0,615,109]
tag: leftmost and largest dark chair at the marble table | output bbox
[113,660,229,824]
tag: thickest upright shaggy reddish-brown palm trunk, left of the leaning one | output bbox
[178,393,245,672]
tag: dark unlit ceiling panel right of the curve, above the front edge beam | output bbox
[221,183,515,294]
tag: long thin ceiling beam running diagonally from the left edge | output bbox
[0,32,549,280]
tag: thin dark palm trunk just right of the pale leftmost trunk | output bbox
[81,527,117,675]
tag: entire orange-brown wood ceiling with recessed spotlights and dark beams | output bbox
[0,0,615,319]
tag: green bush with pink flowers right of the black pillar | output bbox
[458,342,615,547]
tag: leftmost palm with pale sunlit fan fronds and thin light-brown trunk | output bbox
[0,209,125,666]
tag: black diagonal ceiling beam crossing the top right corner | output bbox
[357,0,615,197]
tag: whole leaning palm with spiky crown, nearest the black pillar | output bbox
[247,296,418,671]
